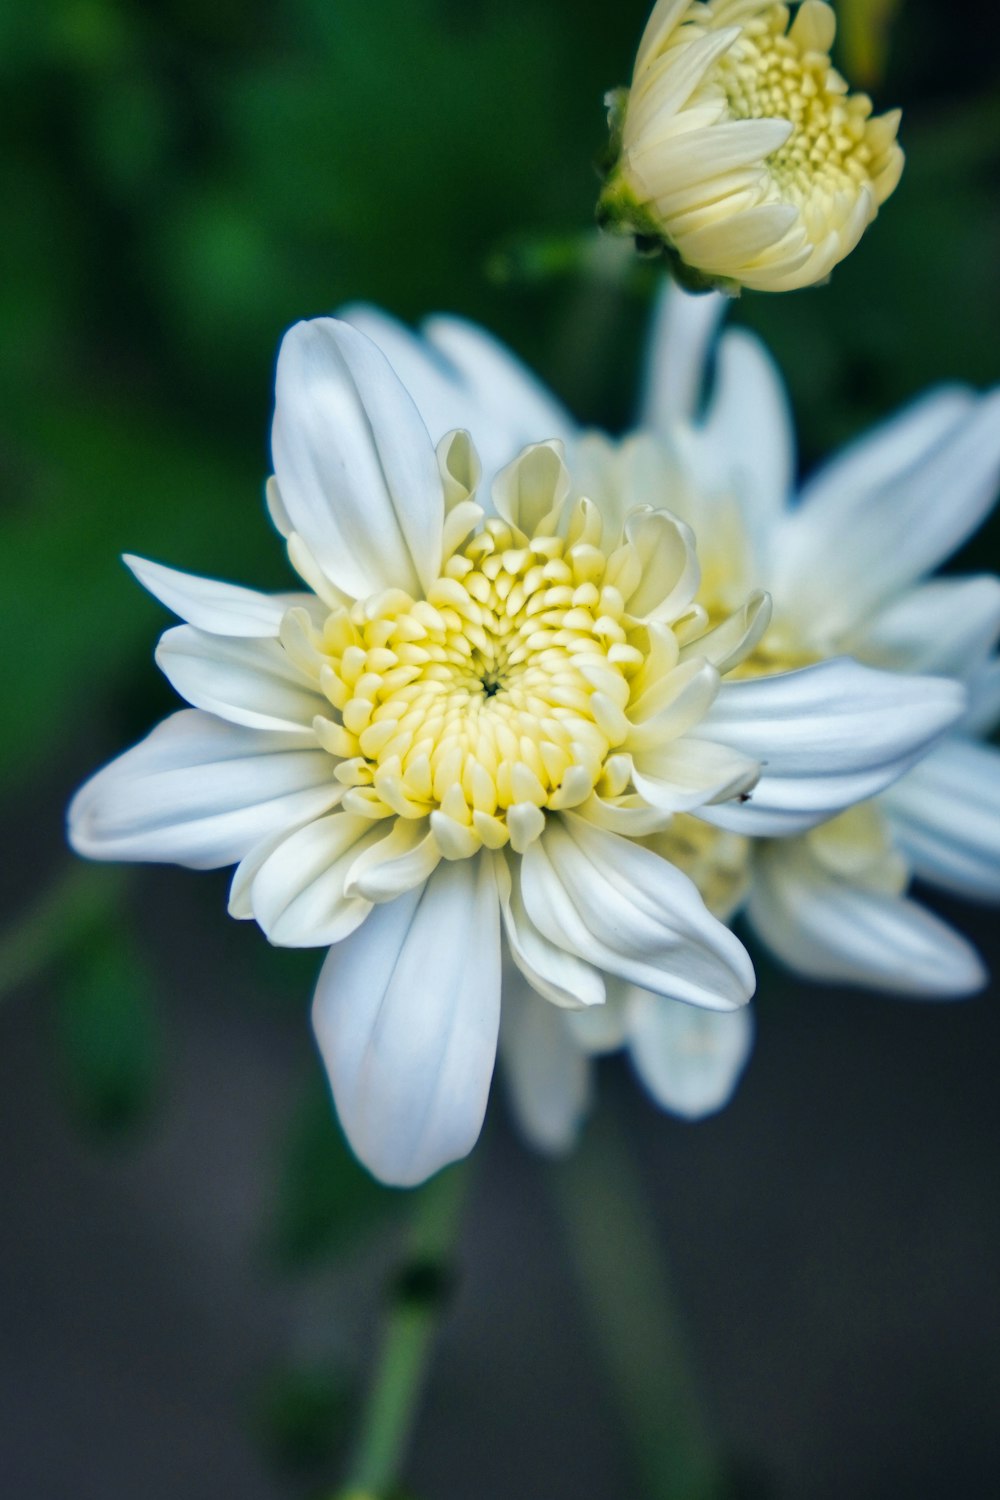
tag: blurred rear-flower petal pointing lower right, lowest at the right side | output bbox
[747,840,987,999]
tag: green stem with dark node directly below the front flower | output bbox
[337,1164,468,1500]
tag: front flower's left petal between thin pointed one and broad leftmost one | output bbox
[156,626,330,744]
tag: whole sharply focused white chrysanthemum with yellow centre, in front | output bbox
[70,320,963,1184]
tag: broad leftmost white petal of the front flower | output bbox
[69,710,342,870]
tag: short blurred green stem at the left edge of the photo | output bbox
[0,861,123,1001]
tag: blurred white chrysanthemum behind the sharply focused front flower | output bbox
[338,301,1000,1151]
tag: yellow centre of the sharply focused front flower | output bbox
[299,507,656,857]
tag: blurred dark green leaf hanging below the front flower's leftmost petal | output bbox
[55,929,160,1131]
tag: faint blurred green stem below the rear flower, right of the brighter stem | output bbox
[552,1107,724,1500]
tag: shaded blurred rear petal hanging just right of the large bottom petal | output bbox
[501,974,591,1157]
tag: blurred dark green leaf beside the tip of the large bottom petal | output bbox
[267,1065,406,1266]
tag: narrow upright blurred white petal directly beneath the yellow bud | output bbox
[639,278,727,437]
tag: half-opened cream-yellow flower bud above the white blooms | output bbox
[598,0,903,291]
